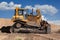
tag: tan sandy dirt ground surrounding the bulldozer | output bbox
[0,18,60,40]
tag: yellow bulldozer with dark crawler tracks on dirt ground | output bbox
[1,7,51,33]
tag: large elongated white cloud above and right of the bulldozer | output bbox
[25,5,58,14]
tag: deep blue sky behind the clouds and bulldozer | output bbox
[0,0,60,21]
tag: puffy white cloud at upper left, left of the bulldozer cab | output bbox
[0,2,21,10]
